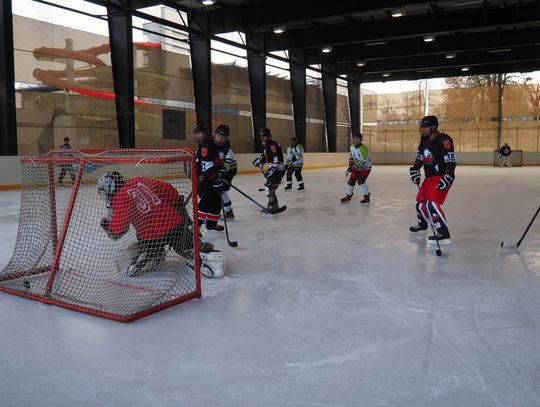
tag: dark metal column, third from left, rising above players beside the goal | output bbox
[188,13,212,132]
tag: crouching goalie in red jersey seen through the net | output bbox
[97,171,221,276]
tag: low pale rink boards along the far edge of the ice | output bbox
[0,152,540,190]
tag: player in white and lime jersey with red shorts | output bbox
[341,133,371,205]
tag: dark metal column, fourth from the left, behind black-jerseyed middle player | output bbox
[246,32,266,152]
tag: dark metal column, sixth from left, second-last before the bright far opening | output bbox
[322,63,337,153]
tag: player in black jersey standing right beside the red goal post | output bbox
[197,124,229,231]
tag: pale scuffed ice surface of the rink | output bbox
[0,166,540,407]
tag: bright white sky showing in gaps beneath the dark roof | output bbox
[12,0,540,93]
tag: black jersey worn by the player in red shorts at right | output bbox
[414,132,456,177]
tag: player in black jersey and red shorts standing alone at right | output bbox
[409,116,456,244]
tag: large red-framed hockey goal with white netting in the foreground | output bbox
[0,149,201,321]
